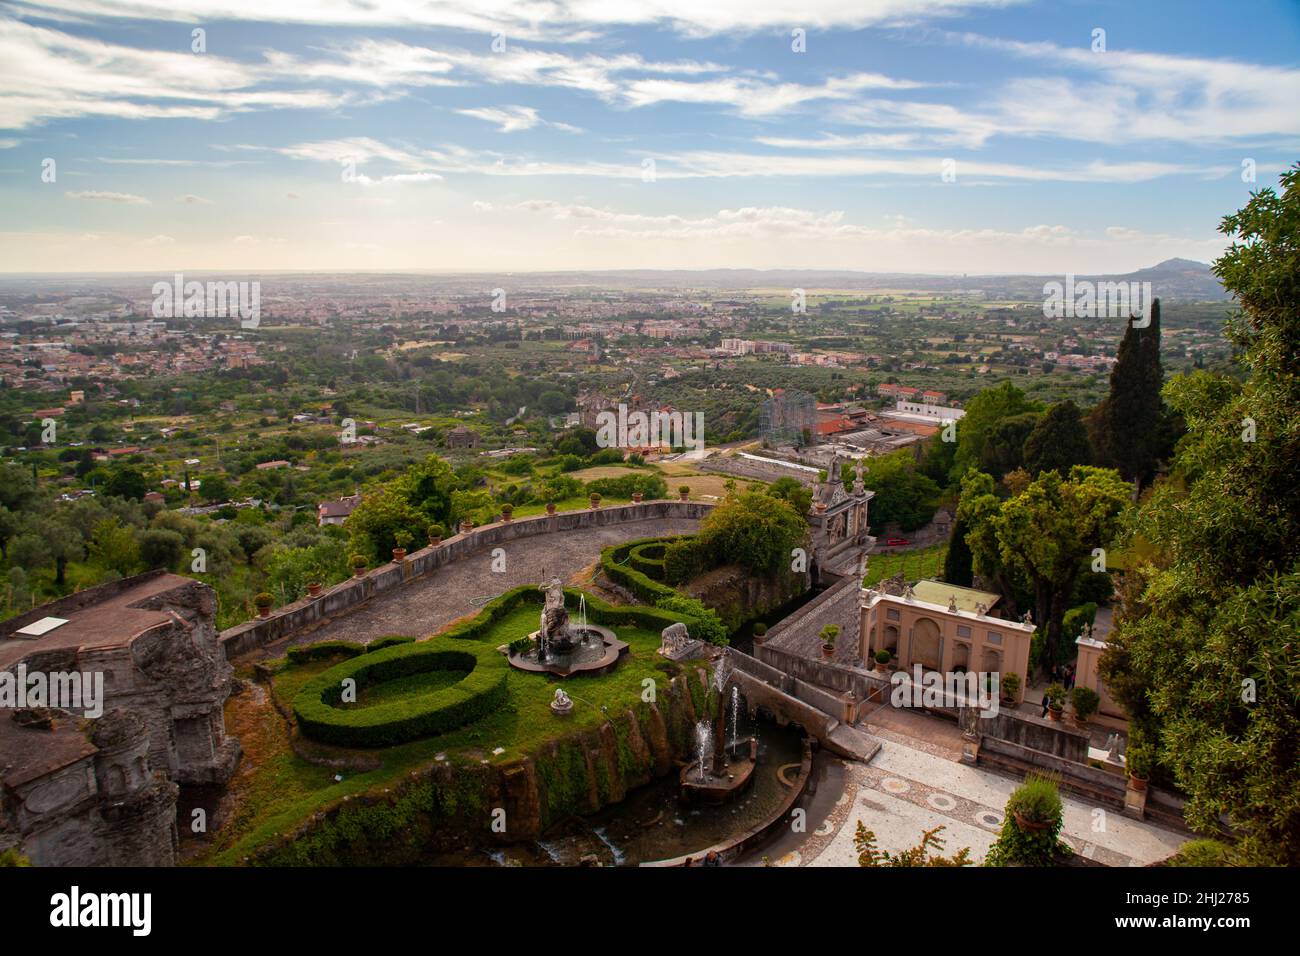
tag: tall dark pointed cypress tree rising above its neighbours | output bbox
[1089,299,1169,486]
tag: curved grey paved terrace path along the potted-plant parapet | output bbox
[263,518,699,657]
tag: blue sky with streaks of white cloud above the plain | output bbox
[0,0,1300,274]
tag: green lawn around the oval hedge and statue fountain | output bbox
[198,595,702,864]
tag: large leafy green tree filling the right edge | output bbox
[1101,165,1300,866]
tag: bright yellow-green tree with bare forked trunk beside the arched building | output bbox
[958,466,1130,661]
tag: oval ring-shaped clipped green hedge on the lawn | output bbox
[294,636,510,747]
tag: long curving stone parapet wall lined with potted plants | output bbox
[221,501,714,659]
